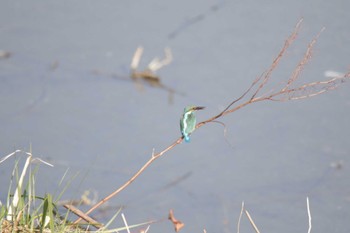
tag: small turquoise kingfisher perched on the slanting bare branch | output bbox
[180,105,205,142]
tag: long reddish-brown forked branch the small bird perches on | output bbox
[75,19,350,224]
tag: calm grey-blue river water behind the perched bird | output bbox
[0,0,350,233]
